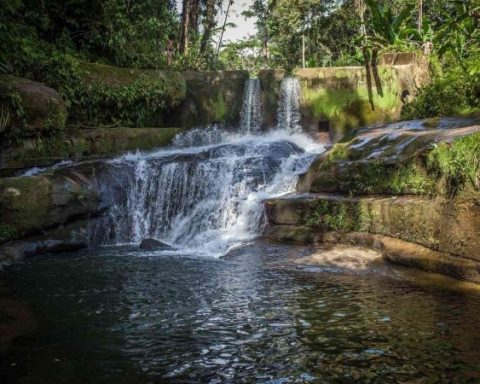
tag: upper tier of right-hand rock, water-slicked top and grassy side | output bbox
[298,119,480,199]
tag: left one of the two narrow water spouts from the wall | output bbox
[240,79,262,134]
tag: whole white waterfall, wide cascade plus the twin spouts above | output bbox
[96,79,324,257]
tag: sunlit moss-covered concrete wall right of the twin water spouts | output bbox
[295,63,429,141]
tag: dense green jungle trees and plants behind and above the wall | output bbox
[0,0,480,123]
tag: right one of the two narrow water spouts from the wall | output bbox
[277,77,302,133]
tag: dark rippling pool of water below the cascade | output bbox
[0,244,480,383]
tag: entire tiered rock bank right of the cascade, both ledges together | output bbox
[265,119,480,283]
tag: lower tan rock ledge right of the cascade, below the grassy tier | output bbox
[266,194,480,261]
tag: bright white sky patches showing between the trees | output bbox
[177,0,255,42]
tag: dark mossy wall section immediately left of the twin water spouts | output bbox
[165,71,249,128]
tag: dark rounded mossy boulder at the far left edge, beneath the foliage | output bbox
[0,75,67,139]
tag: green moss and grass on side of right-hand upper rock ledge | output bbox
[312,133,480,198]
